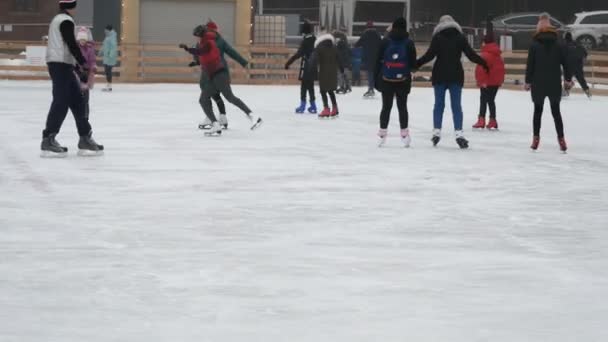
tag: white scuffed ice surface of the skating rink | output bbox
[0,81,608,342]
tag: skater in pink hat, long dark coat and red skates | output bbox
[525,13,572,152]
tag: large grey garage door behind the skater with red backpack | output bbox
[140,0,235,44]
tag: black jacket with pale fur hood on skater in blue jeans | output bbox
[417,21,487,87]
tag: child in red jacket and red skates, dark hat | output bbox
[473,20,505,129]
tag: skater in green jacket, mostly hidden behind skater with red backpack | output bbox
[194,20,248,130]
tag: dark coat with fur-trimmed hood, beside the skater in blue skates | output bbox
[311,34,344,91]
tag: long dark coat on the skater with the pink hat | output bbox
[526,28,572,103]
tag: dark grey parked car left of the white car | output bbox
[492,12,566,50]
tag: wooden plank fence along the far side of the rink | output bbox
[0,41,608,92]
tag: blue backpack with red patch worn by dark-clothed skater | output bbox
[382,38,412,82]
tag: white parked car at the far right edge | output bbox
[567,11,608,50]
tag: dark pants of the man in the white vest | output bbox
[42,63,91,137]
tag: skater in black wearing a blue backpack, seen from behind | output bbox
[374,18,416,147]
